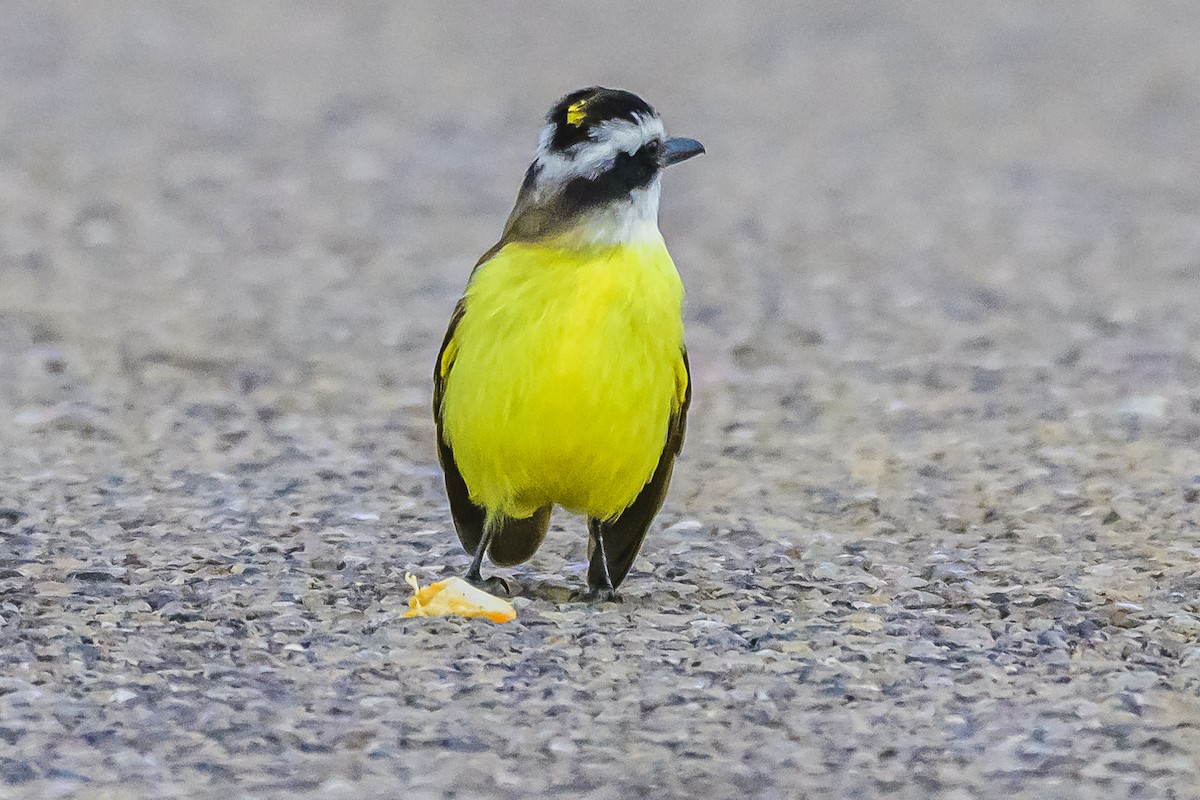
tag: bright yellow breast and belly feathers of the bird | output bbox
[442,237,686,518]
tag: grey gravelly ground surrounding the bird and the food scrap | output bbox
[0,0,1200,800]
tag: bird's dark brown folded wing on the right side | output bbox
[588,349,691,589]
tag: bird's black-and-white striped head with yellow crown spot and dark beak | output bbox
[505,86,704,242]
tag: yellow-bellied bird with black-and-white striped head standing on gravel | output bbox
[433,86,704,602]
